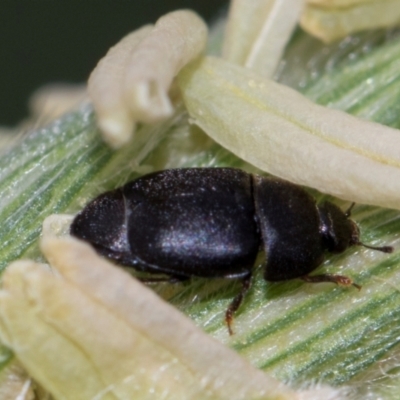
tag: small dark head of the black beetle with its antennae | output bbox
[318,201,393,253]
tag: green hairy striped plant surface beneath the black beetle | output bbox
[0,26,400,399]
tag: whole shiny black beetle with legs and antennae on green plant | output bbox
[70,168,393,334]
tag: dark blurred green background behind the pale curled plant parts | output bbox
[0,0,228,126]
